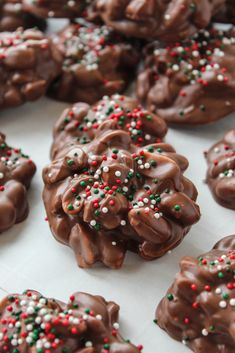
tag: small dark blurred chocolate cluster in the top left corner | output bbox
[0,0,46,32]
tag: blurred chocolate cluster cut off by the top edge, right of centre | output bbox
[96,0,225,41]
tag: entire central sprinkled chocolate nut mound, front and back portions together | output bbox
[43,95,200,268]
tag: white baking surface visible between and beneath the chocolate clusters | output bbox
[0,20,235,353]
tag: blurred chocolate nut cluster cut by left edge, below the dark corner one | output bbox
[0,29,62,108]
